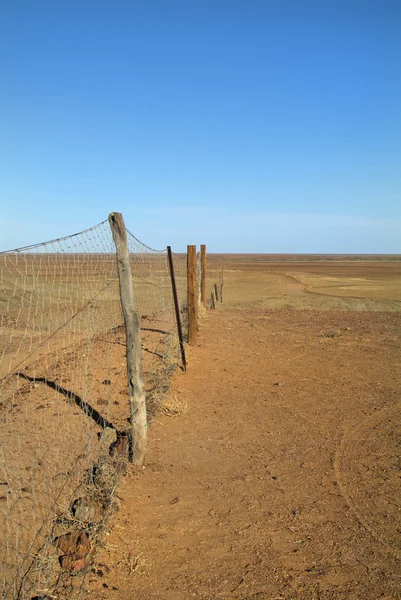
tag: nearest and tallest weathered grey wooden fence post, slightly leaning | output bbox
[109,213,147,466]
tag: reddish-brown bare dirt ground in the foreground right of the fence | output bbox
[89,309,401,600]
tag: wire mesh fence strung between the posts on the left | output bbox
[0,221,186,599]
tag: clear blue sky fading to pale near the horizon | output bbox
[0,0,401,253]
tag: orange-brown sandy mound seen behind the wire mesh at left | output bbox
[0,316,178,600]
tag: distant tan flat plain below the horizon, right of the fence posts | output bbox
[208,254,401,311]
